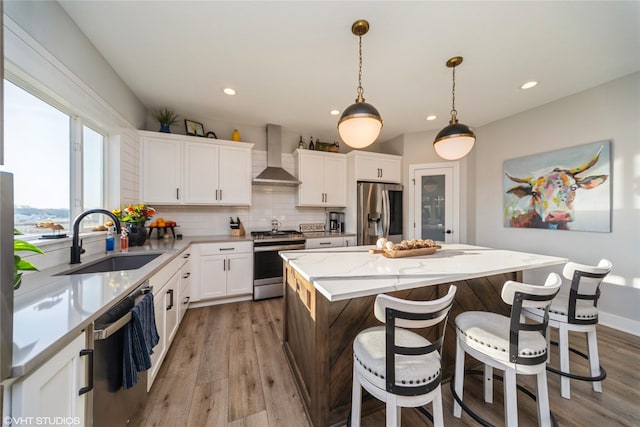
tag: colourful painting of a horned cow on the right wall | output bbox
[503,141,611,233]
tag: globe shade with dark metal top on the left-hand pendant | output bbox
[338,101,382,148]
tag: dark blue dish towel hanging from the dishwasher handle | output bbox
[122,293,160,389]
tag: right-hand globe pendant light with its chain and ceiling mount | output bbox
[433,56,476,160]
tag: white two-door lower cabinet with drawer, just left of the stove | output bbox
[192,241,253,301]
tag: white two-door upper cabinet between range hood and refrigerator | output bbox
[294,150,347,207]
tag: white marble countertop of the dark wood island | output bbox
[280,244,568,301]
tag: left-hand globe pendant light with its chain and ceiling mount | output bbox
[338,19,382,148]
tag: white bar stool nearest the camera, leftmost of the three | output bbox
[351,286,456,427]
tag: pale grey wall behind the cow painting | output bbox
[472,73,640,334]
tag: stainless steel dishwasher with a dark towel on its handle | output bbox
[93,282,152,427]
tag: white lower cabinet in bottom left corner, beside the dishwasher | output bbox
[11,332,90,426]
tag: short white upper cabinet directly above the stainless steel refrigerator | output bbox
[347,151,402,183]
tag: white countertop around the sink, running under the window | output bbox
[11,235,253,378]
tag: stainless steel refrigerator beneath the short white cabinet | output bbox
[357,182,402,245]
